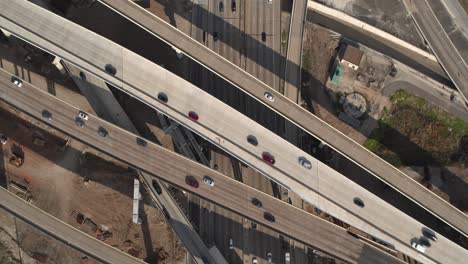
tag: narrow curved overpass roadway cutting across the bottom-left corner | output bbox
[0,188,144,263]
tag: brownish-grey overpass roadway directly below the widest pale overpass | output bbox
[0,72,388,261]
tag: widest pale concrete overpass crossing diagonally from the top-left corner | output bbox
[0,1,463,262]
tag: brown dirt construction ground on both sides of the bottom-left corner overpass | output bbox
[0,102,185,263]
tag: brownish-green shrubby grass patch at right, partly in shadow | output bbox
[364,90,468,166]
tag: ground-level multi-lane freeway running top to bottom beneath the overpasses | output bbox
[190,0,282,263]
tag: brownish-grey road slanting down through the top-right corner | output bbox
[410,0,468,101]
